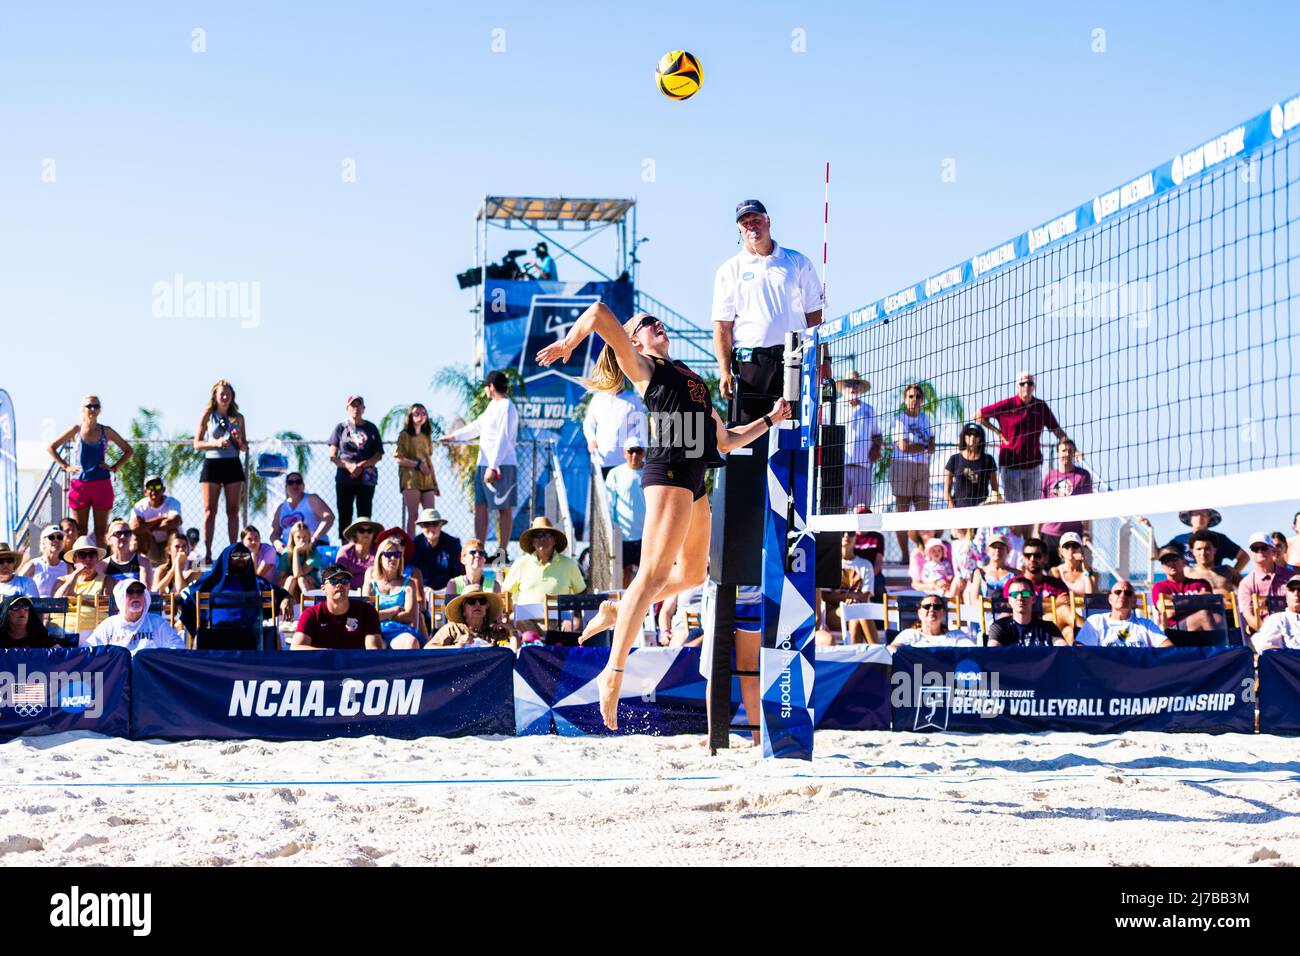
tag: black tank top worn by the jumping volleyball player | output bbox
[642,359,725,468]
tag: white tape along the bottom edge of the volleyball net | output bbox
[809,464,1300,533]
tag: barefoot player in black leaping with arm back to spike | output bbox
[537,302,790,730]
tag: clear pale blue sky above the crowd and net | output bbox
[0,3,1300,546]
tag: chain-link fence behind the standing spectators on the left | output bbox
[25,438,559,551]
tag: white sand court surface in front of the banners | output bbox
[0,732,1300,866]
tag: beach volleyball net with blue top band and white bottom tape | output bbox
[803,96,1300,541]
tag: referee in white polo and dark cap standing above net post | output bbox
[714,199,822,424]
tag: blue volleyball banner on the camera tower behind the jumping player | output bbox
[484,278,633,533]
